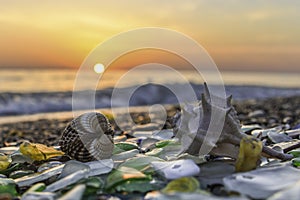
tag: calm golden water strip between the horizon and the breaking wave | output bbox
[0,68,300,93]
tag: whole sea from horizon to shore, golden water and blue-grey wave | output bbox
[0,69,300,116]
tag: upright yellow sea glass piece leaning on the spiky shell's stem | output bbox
[235,136,263,172]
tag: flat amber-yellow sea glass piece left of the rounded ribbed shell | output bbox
[20,142,64,161]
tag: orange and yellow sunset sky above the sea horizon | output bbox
[0,0,300,72]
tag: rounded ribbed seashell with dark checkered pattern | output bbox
[59,112,114,162]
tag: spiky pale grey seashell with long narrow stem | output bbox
[173,83,291,160]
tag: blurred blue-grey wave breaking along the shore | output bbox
[0,84,300,116]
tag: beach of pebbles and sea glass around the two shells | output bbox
[0,96,300,199]
